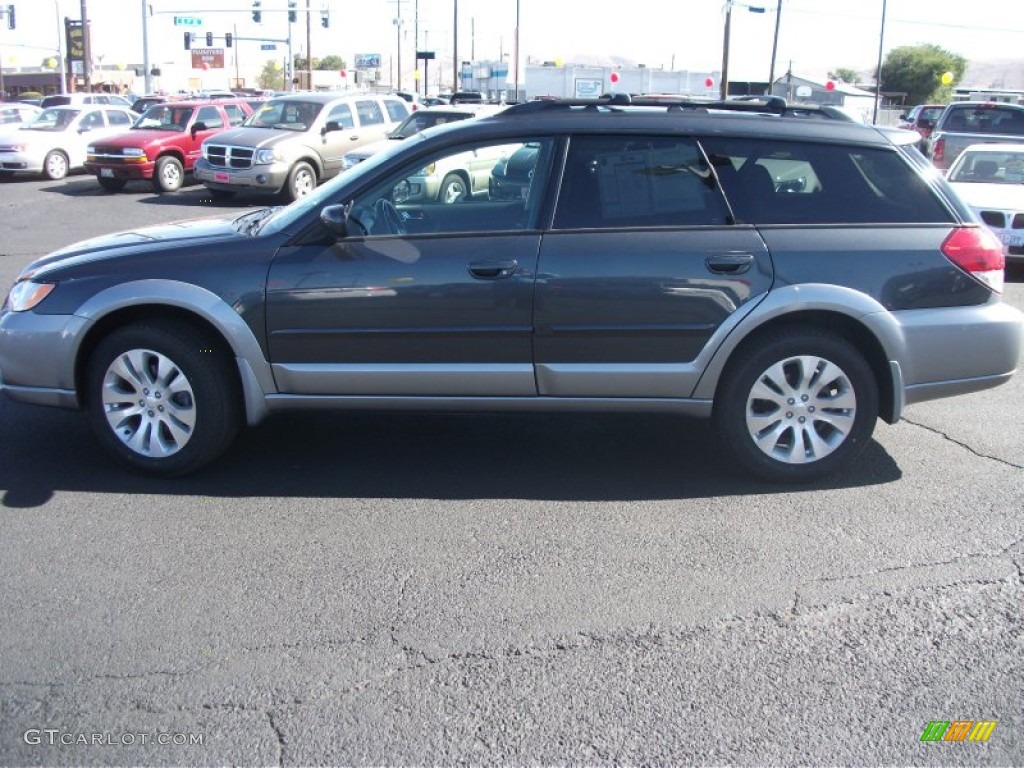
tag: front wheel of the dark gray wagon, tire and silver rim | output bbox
[85,322,242,476]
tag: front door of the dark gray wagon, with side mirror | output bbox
[266,139,551,397]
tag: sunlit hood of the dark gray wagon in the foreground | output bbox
[26,214,245,274]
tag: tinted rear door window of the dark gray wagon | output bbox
[555,136,728,228]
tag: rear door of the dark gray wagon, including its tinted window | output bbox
[534,135,772,397]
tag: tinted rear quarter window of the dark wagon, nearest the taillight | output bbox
[702,138,951,224]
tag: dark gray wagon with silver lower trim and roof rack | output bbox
[0,98,1022,481]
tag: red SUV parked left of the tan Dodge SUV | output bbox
[85,98,253,193]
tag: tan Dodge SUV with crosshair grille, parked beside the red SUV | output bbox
[196,92,410,202]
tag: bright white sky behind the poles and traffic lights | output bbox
[0,0,1024,87]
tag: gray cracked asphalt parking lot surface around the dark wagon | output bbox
[0,176,1024,766]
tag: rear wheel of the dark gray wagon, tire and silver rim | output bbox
[713,327,879,482]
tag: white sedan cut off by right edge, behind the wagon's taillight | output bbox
[946,143,1024,262]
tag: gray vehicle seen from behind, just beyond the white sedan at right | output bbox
[928,101,1024,170]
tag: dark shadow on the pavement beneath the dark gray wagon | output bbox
[0,402,901,508]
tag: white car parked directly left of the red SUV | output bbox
[0,104,138,179]
